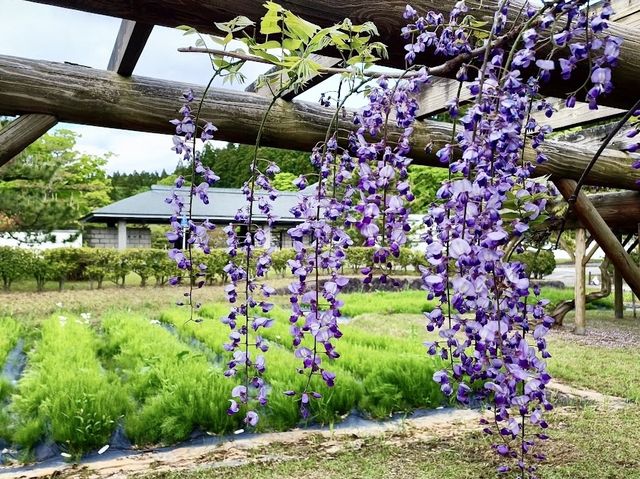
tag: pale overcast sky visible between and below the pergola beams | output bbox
[0,0,372,172]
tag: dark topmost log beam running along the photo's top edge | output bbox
[30,0,640,108]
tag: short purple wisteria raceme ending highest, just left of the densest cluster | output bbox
[345,72,429,284]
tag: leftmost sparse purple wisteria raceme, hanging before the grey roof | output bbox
[166,91,220,320]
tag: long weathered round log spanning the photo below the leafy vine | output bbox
[0,56,639,190]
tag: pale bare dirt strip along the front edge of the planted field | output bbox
[0,382,625,479]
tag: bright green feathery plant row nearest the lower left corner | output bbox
[5,316,126,455]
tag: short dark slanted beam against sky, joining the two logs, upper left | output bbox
[107,20,153,77]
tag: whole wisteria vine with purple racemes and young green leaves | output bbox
[168,0,640,479]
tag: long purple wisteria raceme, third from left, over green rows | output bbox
[285,130,355,418]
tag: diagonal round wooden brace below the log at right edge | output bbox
[554,179,640,294]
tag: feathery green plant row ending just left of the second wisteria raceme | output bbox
[102,313,238,445]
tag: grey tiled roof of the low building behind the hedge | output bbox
[84,185,315,223]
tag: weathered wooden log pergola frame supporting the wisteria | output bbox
[0,0,640,302]
